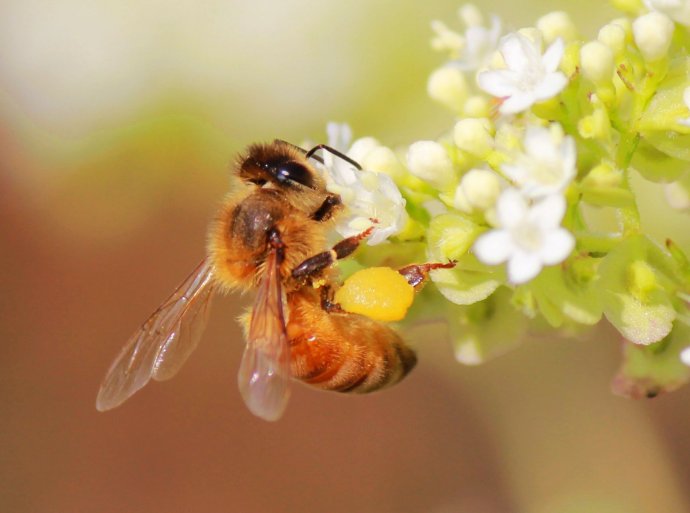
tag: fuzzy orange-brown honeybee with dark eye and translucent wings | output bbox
[96,140,452,421]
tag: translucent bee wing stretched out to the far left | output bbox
[96,260,215,411]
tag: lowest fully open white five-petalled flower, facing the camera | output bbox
[474,189,575,284]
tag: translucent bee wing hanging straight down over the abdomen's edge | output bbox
[237,251,290,421]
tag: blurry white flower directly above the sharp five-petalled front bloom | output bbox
[501,123,576,198]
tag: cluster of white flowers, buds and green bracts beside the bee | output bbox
[316,0,690,397]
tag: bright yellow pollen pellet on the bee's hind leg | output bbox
[334,267,414,321]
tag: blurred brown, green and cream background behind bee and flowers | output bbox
[0,0,690,513]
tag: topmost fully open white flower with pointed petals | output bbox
[477,32,568,114]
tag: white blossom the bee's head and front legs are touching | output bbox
[318,123,407,246]
